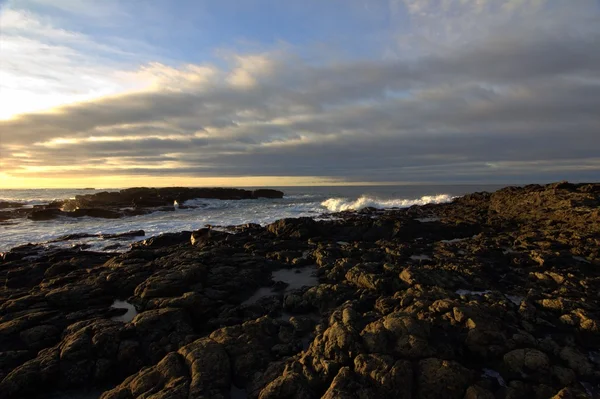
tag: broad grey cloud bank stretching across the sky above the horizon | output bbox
[0,0,600,181]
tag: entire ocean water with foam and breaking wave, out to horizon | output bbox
[0,185,504,252]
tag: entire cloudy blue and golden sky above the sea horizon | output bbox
[0,0,600,188]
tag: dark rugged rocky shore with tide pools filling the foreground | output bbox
[0,183,600,399]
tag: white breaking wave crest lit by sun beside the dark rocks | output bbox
[321,194,454,212]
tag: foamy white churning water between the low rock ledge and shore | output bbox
[0,189,460,251]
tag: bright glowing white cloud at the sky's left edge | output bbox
[0,7,158,119]
